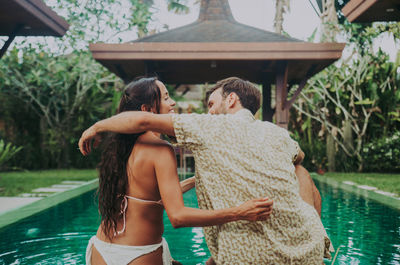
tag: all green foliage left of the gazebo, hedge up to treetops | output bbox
[0,0,188,169]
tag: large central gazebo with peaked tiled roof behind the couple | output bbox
[90,0,345,128]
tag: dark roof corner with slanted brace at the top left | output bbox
[0,0,69,58]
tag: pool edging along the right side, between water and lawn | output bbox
[310,173,400,210]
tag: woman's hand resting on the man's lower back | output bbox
[237,198,273,221]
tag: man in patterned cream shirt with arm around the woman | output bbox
[79,78,330,265]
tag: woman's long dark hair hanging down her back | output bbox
[98,77,161,239]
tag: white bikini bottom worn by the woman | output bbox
[86,236,172,265]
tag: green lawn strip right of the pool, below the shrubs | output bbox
[325,172,400,196]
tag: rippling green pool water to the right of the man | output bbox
[316,180,400,264]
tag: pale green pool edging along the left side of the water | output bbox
[0,179,99,230]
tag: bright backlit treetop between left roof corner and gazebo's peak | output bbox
[48,0,189,44]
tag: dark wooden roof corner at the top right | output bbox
[342,0,400,22]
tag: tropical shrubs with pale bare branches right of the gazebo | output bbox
[292,20,400,171]
